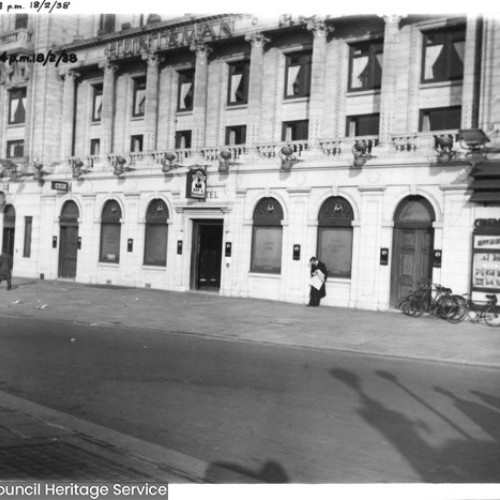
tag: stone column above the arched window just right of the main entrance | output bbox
[245,32,270,149]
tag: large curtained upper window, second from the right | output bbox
[349,40,384,92]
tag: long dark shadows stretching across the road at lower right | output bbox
[330,368,500,483]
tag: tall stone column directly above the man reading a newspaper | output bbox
[307,17,333,154]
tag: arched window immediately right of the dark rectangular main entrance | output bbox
[250,198,283,274]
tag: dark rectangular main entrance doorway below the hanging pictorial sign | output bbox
[191,220,224,291]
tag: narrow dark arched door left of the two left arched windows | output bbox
[58,201,80,278]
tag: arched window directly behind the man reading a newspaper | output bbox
[317,196,354,278]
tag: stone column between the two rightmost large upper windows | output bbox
[378,16,402,152]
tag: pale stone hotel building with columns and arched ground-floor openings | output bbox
[0,14,500,310]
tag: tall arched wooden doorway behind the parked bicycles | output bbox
[391,196,436,307]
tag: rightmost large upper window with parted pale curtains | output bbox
[422,26,465,83]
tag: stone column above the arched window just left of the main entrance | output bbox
[142,53,162,151]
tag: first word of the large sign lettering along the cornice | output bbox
[105,18,234,59]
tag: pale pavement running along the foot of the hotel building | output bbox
[0,278,500,368]
